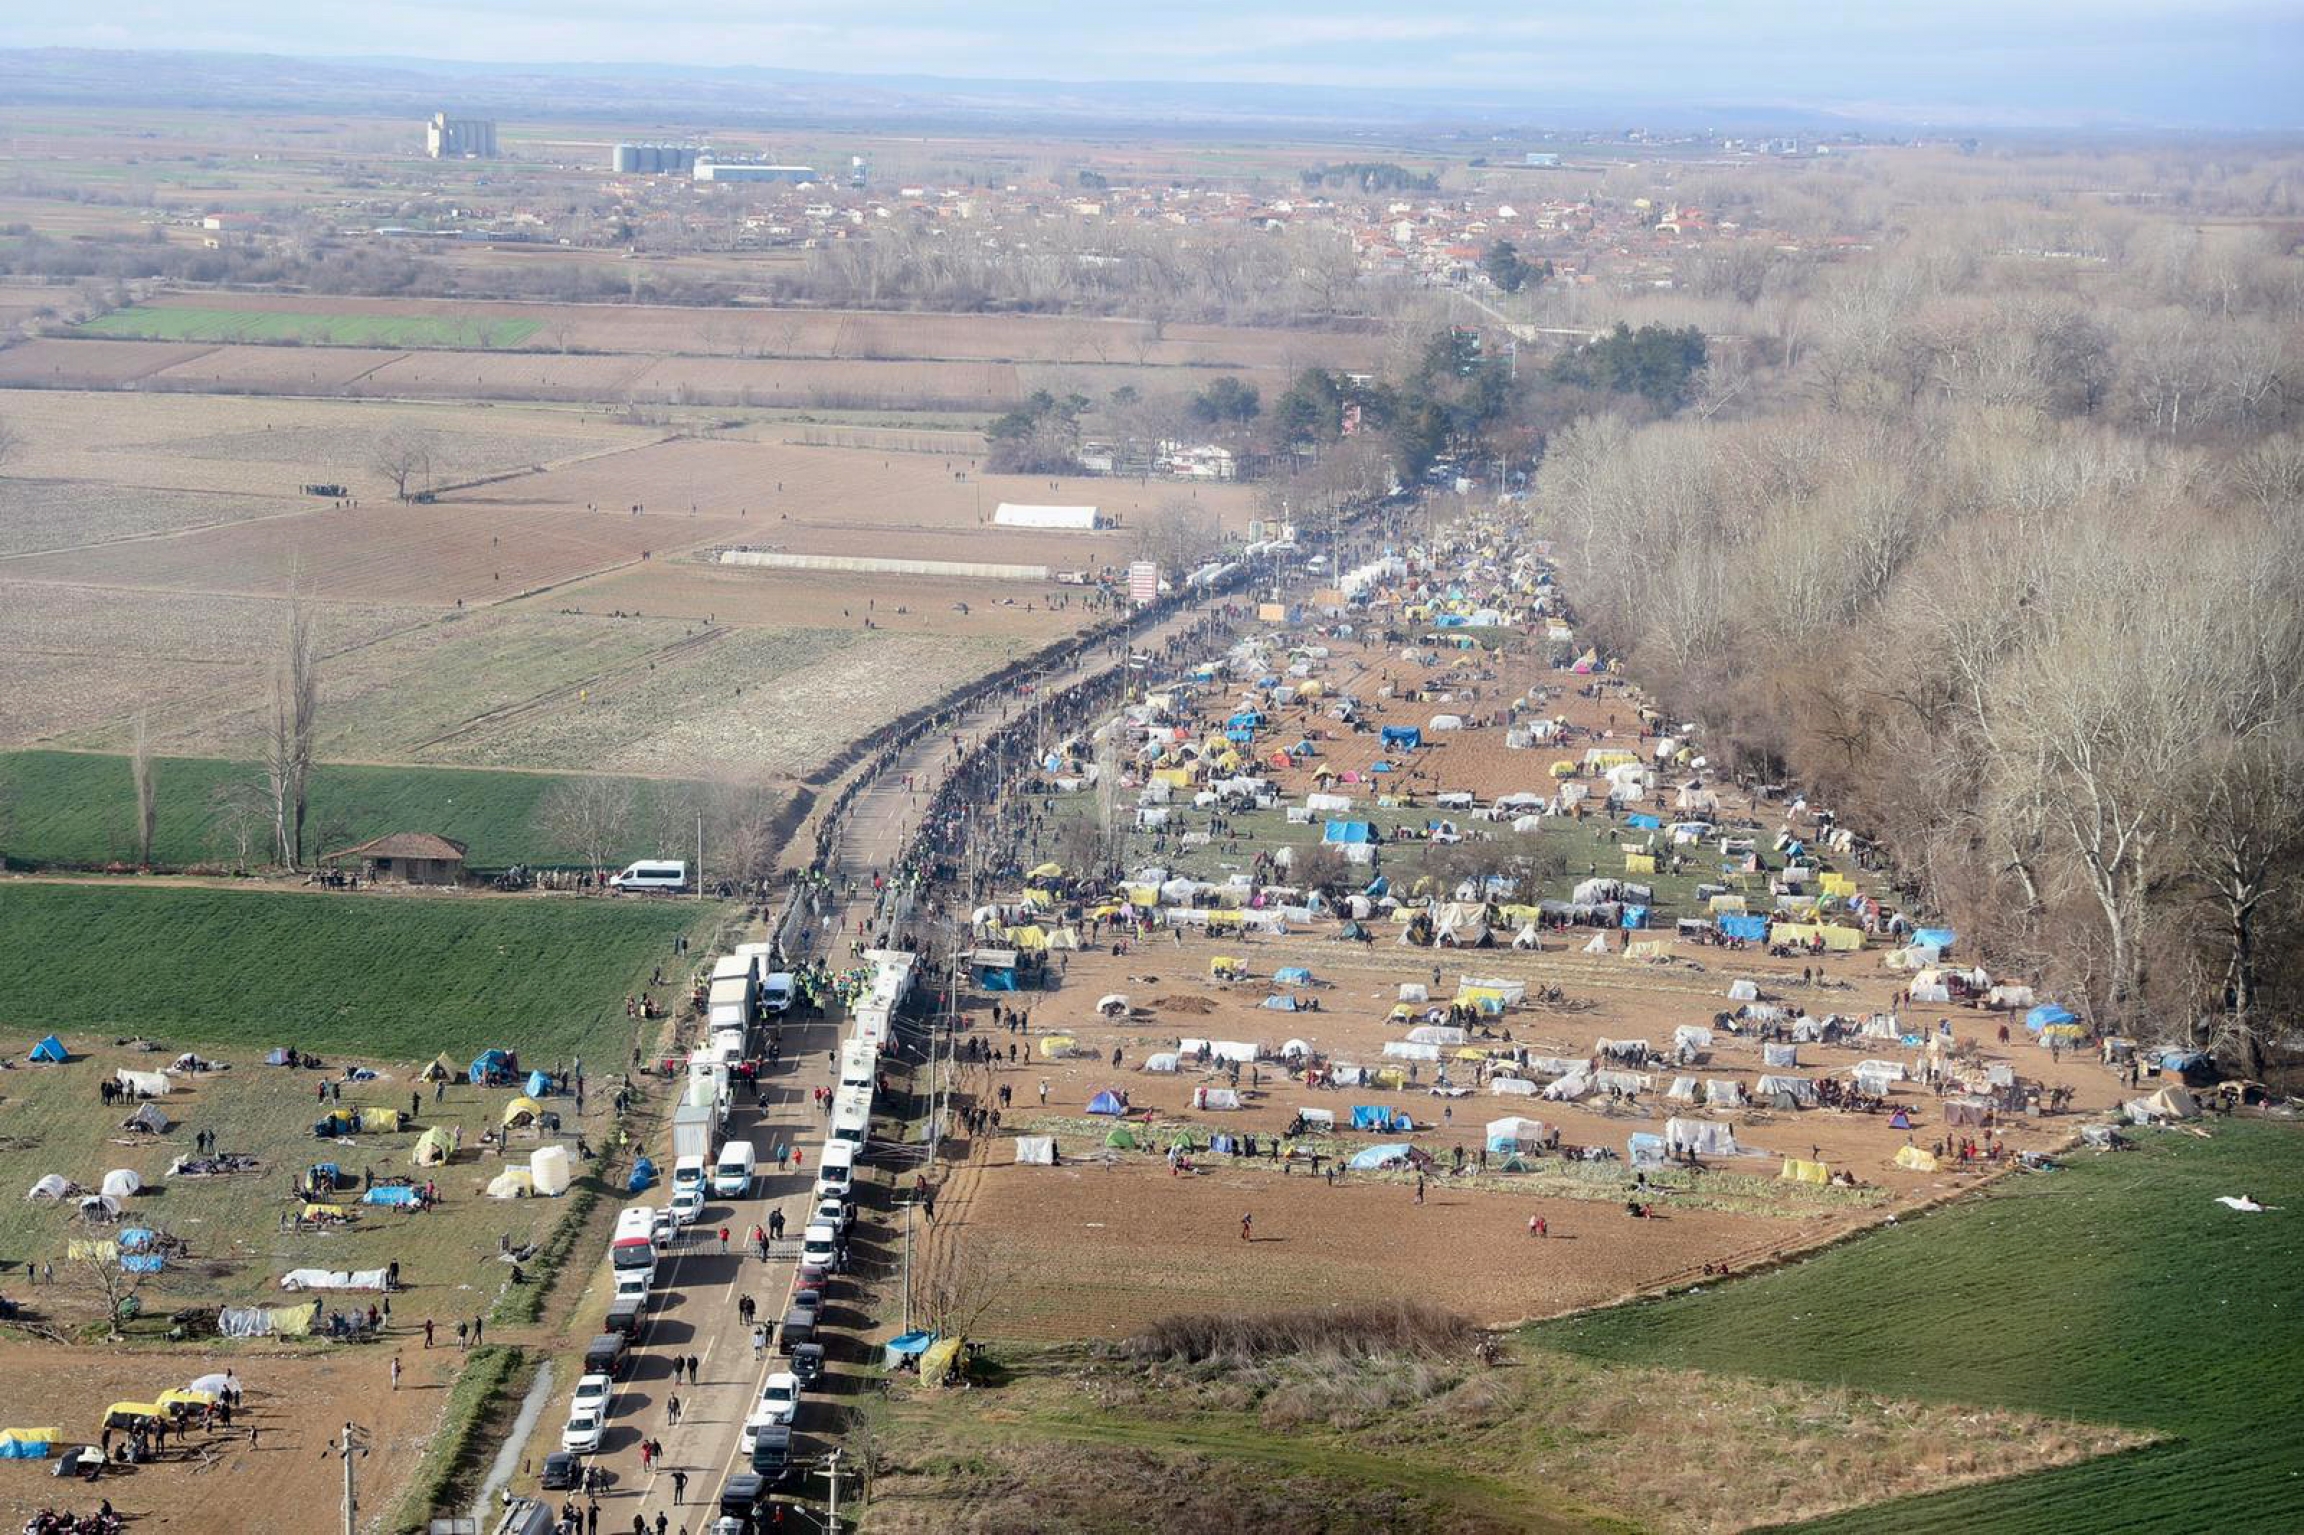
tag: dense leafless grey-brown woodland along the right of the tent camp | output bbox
[1537,200,2304,1072]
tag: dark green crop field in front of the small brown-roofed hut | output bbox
[0,883,723,1063]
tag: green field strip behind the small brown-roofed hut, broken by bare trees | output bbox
[0,751,695,869]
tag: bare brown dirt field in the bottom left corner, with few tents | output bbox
[0,1337,456,1535]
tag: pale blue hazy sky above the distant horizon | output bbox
[18,0,2304,127]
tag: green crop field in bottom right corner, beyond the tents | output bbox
[1530,1122,2304,1535]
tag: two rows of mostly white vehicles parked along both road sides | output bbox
[529,943,915,1535]
